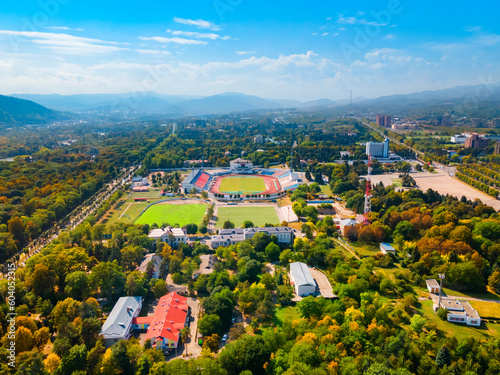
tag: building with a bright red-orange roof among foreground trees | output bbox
[133,292,190,350]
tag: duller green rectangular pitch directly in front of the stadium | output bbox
[215,206,279,228]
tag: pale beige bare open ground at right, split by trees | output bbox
[364,168,500,210]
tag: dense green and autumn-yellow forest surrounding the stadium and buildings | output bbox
[0,118,500,375]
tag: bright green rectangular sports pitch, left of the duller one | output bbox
[134,204,207,227]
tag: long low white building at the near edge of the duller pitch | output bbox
[211,227,295,249]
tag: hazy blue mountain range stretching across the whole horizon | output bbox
[0,83,500,125]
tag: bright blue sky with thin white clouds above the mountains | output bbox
[0,0,500,101]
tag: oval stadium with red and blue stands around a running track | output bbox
[182,159,299,200]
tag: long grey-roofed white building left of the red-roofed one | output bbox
[101,297,142,347]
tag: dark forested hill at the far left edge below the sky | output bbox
[0,95,66,127]
